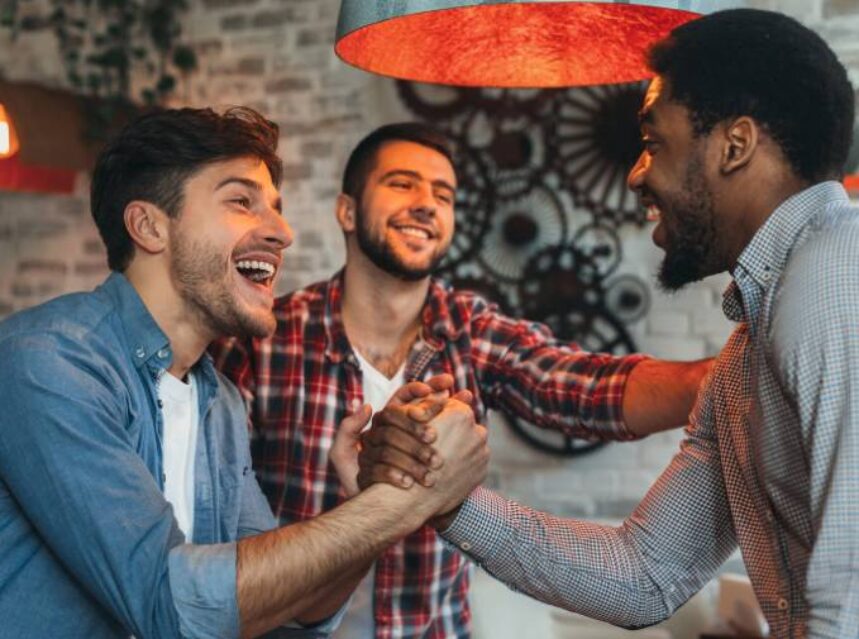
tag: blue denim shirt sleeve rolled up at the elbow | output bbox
[0,334,238,639]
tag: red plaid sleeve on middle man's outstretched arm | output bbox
[472,306,644,440]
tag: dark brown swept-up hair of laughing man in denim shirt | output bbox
[90,107,283,271]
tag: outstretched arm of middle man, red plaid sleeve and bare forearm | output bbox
[471,307,712,440]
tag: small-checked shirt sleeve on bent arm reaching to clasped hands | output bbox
[443,364,736,628]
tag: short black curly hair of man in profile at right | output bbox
[649,9,855,183]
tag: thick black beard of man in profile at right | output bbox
[658,155,722,292]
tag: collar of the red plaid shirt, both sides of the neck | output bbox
[323,269,466,362]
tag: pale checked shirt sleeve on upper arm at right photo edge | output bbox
[770,224,859,639]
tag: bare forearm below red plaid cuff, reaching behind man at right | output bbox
[623,359,714,437]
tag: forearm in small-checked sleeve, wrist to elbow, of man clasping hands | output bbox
[443,489,673,628]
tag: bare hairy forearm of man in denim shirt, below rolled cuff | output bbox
[237,485,432,637]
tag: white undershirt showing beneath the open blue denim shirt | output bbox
[158,372,199,541]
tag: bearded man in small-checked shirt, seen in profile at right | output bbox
[368,9,859,639]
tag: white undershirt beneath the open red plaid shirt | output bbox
[334,350,406,639]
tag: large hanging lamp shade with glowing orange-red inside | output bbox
[335,0,712,88]
